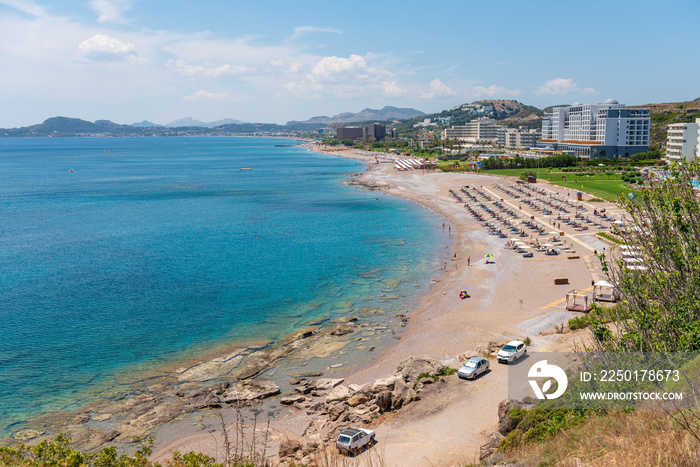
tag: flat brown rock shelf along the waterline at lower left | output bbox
[5,310,408,450]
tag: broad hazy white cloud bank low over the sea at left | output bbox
[0,0,442,126]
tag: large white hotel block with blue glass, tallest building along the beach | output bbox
[537,99,649,159]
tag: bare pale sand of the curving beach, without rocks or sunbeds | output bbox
[146,144,620,466]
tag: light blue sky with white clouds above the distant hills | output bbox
[0,0,700,128]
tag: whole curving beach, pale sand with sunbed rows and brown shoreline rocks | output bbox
[6,143,621,466]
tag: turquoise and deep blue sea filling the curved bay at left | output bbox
[0,138,449,435]
